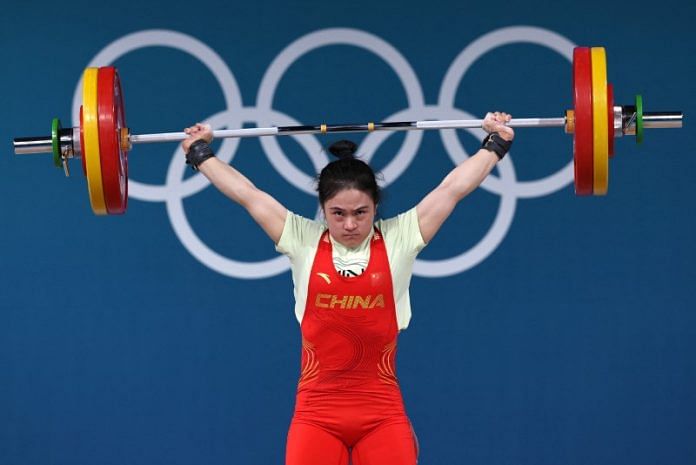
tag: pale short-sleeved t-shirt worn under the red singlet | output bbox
[276,207,426,330]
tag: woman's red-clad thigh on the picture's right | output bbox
[352,420,418,465]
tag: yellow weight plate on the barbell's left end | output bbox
[82,68,107,215]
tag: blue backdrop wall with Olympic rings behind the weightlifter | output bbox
[0,0,696,465]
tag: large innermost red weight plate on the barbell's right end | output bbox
[573,47,594,195]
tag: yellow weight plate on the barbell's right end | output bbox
[591,47,614,195]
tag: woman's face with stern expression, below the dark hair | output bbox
[323,189,376,247]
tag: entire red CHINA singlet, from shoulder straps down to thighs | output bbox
[286,230,418,465]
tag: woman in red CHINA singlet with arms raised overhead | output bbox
[182,112,514,465]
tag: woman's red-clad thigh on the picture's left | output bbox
[285,422,348,465]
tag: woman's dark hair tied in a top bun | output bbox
[317,140,380,205]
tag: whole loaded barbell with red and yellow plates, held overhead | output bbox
[14,47,683,215]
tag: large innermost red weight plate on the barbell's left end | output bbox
[97,66,128,215]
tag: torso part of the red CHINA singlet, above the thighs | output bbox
[293,231,405,443]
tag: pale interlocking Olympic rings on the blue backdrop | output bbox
[72,27,575,279]
